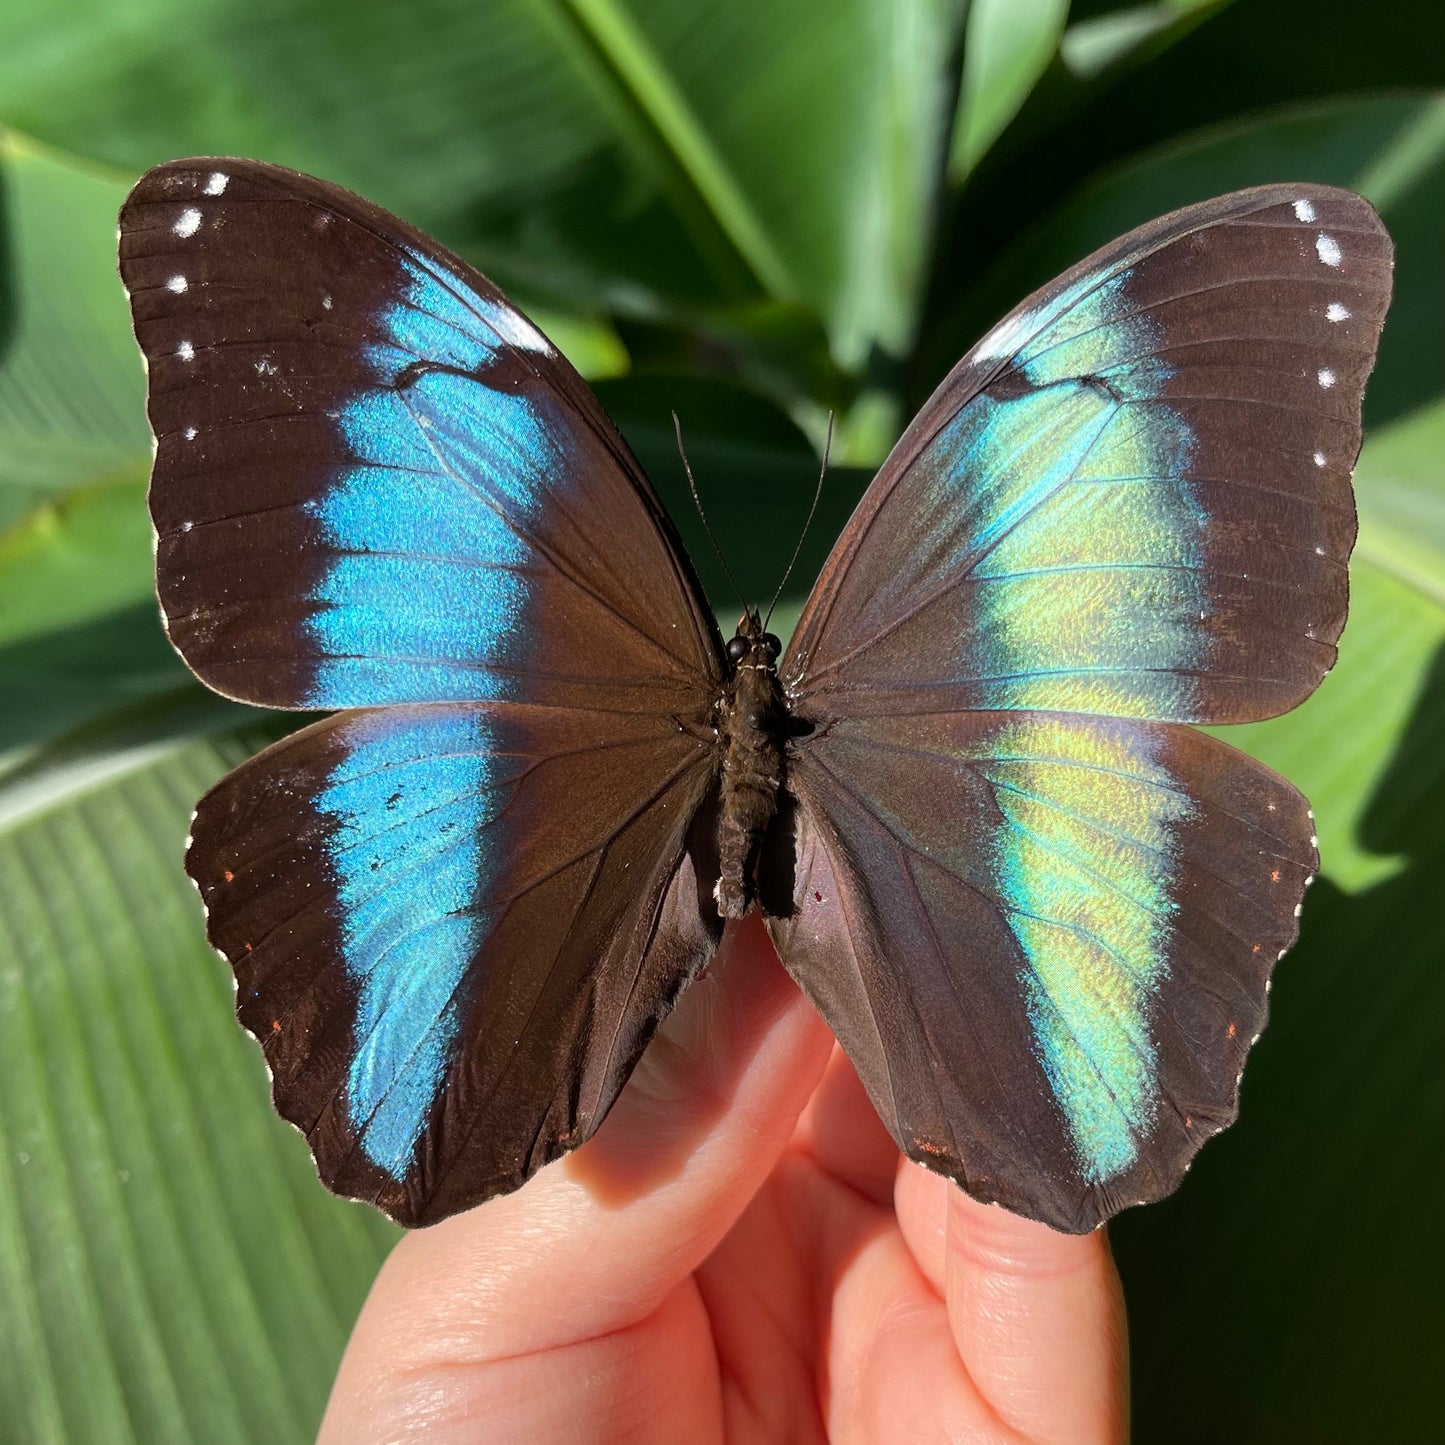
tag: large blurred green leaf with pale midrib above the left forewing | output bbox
[0,0,958,366]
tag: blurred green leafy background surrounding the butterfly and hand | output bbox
[0,0,1445,1445]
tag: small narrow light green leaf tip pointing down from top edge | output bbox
[948,0,1069,181]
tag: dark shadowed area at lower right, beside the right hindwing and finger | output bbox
[1113,647,1445,1445]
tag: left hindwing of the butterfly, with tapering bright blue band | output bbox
[186,702,718,1224]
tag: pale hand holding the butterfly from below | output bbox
[321,913,1127,1445]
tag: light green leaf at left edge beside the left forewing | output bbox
[0,136,189,757]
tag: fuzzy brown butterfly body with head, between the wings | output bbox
[715,608,788,918]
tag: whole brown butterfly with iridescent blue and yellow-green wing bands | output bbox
[120,160,1392,1231]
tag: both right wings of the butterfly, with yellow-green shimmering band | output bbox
[769,185,1392,1230]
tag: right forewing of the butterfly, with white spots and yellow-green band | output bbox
[783,186,1392,723]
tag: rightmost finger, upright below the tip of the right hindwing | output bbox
[936,1186,1127,1445]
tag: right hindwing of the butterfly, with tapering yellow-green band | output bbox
[770,712,1316,1233]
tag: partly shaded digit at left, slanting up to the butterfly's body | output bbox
[322,919,829,1398]
